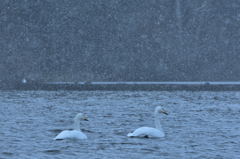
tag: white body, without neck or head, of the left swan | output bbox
[54,130,87,140]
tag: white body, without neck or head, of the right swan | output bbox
[127,127,165,137]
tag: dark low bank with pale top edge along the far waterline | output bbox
[0,82,240,91]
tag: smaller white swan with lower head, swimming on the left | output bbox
[54,113,87,140]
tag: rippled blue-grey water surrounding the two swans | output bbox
[0,91,240,159]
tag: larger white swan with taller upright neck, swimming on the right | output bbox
[127,106,168,137]
